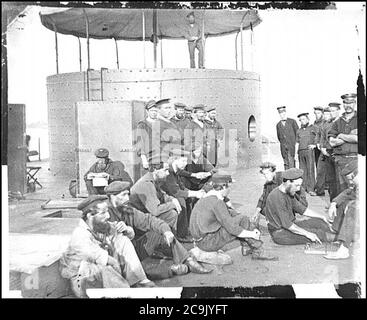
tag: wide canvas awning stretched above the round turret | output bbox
[40,8,261,41]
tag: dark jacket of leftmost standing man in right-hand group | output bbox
[276,118,298,156]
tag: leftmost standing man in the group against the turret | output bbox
[136,100,158,173]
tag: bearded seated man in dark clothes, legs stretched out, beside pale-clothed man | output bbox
[105,181,212,274]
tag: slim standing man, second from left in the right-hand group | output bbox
[296,112,317,196]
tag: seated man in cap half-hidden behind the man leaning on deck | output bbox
[251,162,308,227]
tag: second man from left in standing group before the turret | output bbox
[154,99,183,159]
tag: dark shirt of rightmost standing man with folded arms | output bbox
[328,112,358,155]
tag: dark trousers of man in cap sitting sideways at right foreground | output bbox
[268,218,331,245]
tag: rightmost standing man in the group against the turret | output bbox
[204,105,224,167]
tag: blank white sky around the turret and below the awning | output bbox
[7,2,366,148]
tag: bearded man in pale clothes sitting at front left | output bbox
[60,195,155,297]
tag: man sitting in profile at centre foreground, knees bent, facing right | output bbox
[190,173,278,260]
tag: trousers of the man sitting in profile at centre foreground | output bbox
[196,214,255,251]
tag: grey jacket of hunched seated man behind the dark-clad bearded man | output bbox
[130,172,176,216]
